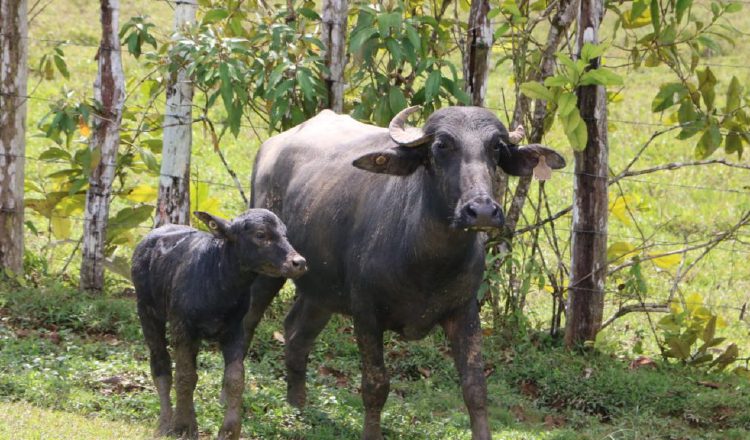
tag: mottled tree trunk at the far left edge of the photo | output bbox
[0,0,29,274]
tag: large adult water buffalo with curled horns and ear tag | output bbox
[245,107,565,439]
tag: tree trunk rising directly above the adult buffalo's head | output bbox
[464,0,493,107]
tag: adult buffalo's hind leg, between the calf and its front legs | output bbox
[284,294,331,408]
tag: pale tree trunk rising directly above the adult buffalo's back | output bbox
[321,0,348,113]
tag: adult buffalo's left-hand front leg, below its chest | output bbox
[354,310,390,440]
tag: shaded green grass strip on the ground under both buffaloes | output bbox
[0,285,750,440]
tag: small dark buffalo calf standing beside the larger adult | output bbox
[132,209,306,439]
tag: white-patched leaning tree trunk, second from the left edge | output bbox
[80,0,125,291]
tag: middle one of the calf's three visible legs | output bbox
[172,327,200,439]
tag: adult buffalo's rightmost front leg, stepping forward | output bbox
[442,301,490,440]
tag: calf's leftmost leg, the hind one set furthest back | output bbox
[138,304,172,436]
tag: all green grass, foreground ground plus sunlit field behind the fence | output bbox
[0,0,750,440]
